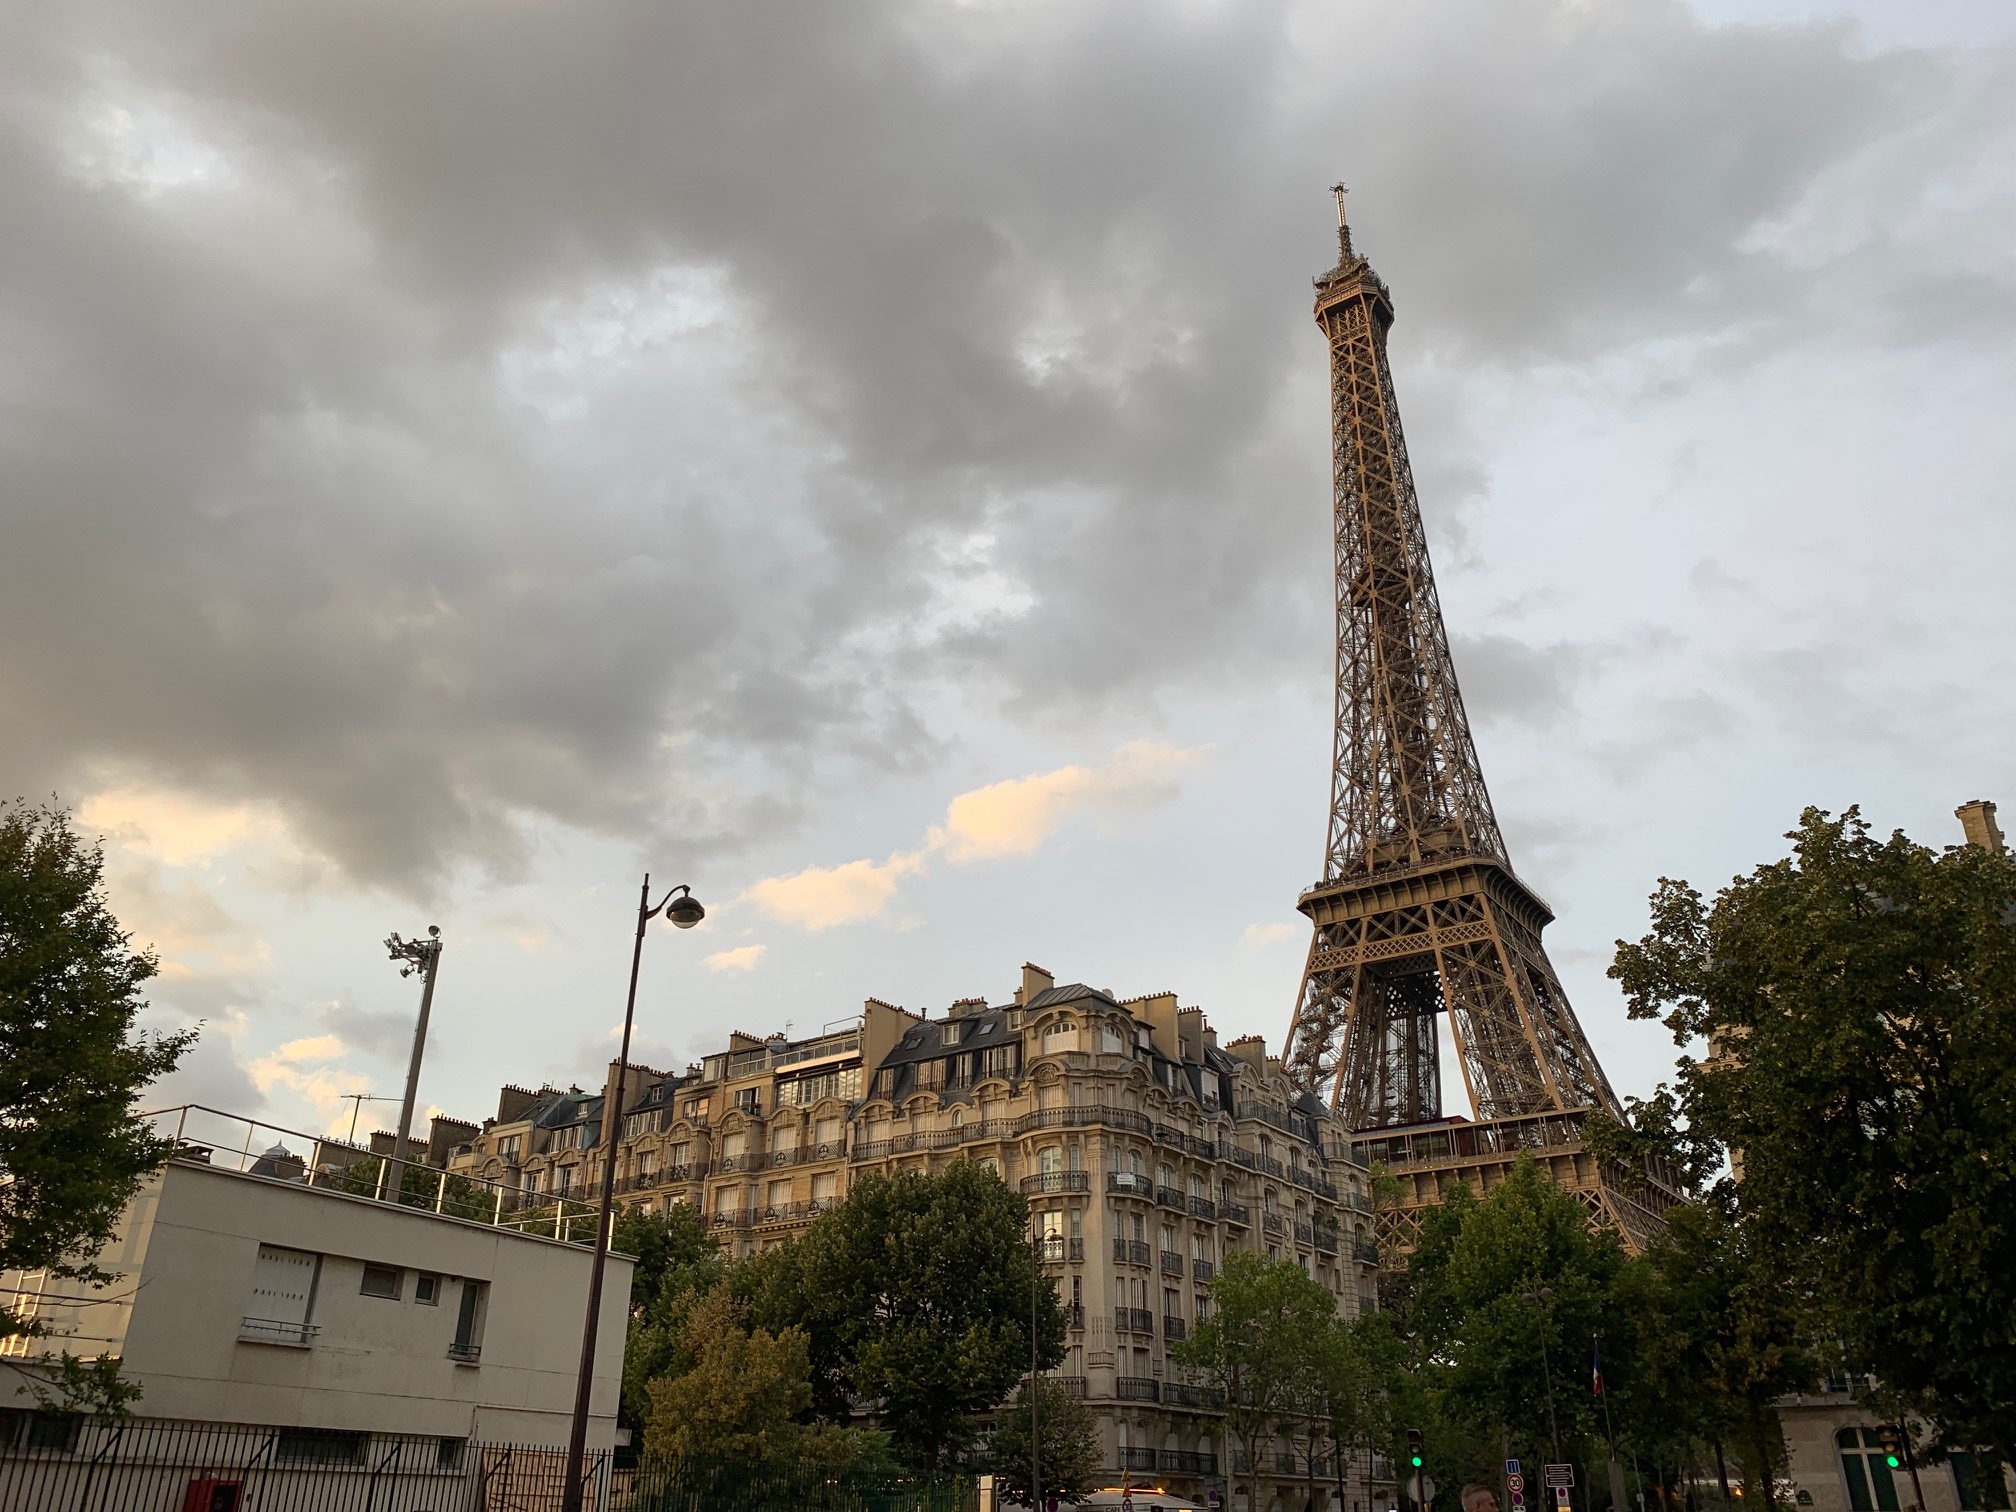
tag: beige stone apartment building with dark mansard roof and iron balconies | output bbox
[452,966,1377,1508]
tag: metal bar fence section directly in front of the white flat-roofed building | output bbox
[0,1411,612,1512]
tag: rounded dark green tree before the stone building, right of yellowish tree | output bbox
[762,1161,1064,1470]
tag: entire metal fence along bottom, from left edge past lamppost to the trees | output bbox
[0,1409,978,1512]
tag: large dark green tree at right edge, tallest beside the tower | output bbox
[1611,808,2016,1460]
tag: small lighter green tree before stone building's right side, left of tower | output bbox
[1169,1250,1337,1507]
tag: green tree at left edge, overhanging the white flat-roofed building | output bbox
[0,802,196,1370]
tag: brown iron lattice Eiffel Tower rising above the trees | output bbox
[1284,183,1677,1256]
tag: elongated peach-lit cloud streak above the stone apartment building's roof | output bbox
[742,740,1204,929]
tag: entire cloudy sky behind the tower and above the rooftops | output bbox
[0,0,2016,1129]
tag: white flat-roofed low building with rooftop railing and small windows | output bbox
[0,1111,631,1447]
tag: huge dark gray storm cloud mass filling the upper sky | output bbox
[0,0,2010,889]
